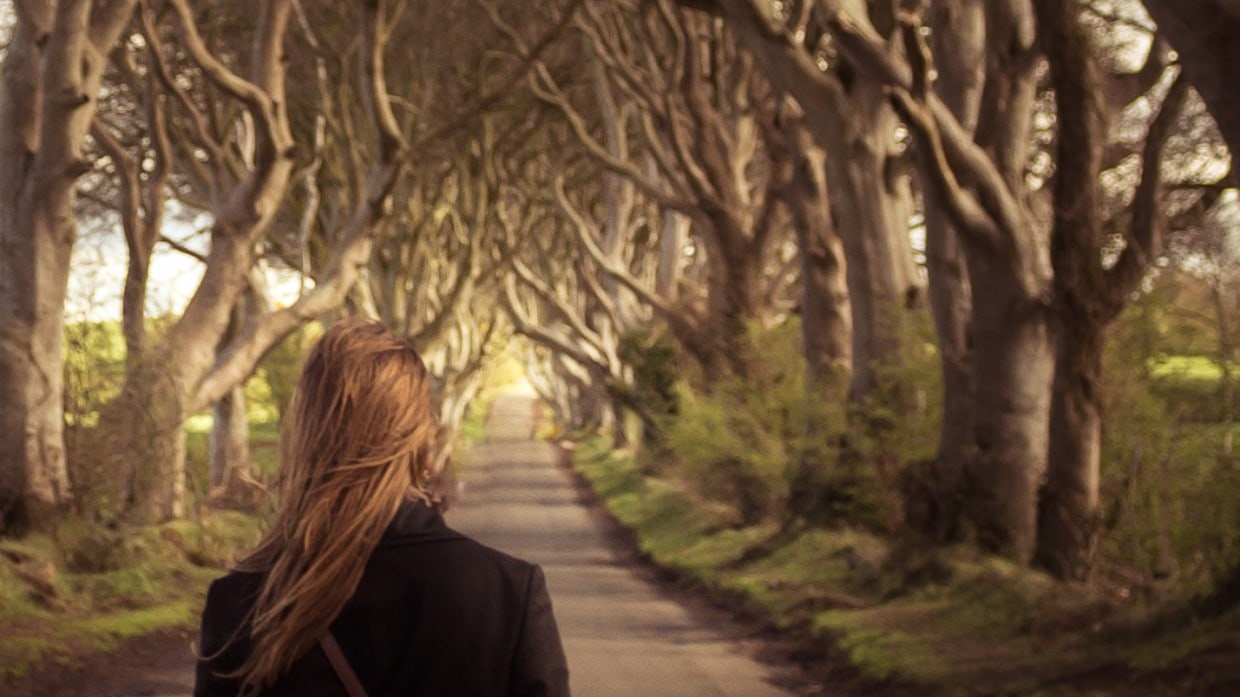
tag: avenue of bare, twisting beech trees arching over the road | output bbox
[0,0,1240,634]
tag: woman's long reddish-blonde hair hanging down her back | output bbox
[234,319,436,695]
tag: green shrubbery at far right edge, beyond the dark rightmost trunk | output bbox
[1097,294,1240,593]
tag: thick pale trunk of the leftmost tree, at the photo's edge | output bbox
[0,0,135,533]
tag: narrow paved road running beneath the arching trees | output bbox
[448,392,792,697]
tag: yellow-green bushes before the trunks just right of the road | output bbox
[666,317,942,530]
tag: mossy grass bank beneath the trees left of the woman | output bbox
[0,511,258,686]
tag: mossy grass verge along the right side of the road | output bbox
[574,442,1240,697]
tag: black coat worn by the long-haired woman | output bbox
[193,504,568,697]
